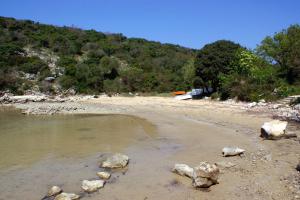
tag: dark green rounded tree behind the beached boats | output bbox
[195,40,242,91]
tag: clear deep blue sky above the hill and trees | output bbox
[0,0,300,49]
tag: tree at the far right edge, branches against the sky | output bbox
[257,25,300,84]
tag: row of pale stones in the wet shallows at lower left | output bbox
[43,153,129,200]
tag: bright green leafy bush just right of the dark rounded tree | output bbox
[219,50,279,101]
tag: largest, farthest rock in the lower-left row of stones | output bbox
[100,153,129,168]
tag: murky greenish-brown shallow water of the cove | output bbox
[0,109,156,168]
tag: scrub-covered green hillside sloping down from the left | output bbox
[0,17,195,93]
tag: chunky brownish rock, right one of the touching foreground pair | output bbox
[193,162,220,188]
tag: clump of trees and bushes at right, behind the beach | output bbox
[194,25,300,101]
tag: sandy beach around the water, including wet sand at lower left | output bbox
[0,97,300,200]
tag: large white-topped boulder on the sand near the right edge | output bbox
[260,120,288,139]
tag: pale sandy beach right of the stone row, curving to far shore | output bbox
[0,96,300,200]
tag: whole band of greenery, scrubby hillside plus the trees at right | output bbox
[0,17,300,101]
